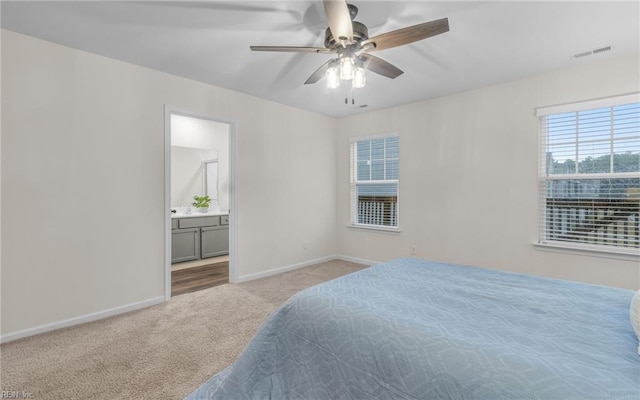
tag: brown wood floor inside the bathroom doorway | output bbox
[171,261,229,297]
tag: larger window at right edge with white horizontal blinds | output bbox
[537,94,640,255]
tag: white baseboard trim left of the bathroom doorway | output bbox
[0,296,165,343]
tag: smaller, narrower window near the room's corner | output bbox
[350,136,399,229]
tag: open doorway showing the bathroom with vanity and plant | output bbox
[165,108,235,300]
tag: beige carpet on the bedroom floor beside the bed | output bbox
[0,261,364,400]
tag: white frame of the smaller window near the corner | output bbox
[347,133,400,233]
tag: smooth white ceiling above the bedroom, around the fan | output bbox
[1,0,640,117]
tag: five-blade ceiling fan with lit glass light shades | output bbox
[250,0,449,88]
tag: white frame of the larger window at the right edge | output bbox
[535,93,640,260]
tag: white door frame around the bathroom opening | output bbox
[164,104,240,301]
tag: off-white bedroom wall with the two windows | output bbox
[337,53,640,289]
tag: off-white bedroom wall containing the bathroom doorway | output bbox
[1,30,336,338]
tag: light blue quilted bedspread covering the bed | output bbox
[187,259,640,400]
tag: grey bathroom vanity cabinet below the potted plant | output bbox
[171,214,229,264]
